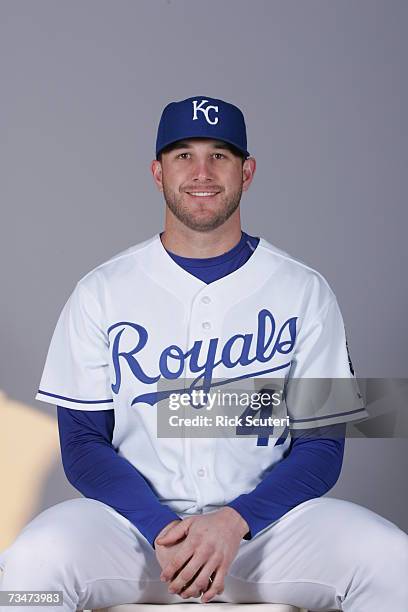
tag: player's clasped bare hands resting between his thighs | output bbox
[155,506,249,603]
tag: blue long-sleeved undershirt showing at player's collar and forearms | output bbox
[57,232,346,547]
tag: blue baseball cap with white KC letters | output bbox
[156,96,250,158]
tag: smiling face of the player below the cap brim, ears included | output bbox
[152,138,255,232]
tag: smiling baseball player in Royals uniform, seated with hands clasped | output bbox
[0,96,408,612]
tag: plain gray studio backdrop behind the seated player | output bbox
[0,0,408,531]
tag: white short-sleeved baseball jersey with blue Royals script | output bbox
[36,234,368,514]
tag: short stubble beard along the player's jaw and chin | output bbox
[163,183,242,232]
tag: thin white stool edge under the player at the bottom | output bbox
[90,602,307,612]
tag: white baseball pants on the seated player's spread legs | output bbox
[0,498,408,612]
